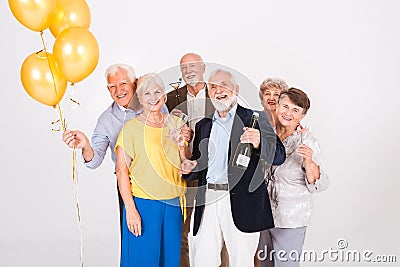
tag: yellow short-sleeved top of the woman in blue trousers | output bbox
[115,118,186,200]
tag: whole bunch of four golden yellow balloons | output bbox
[8,0,99,106]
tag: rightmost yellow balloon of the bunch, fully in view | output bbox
[53,27,99,83]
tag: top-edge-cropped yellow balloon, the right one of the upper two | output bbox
[50,0,90,38]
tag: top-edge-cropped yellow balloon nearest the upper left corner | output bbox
[8,0,56,32]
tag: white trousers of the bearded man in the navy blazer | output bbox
[189,189,260,267]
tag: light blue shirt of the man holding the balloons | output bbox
[85,102,168,169]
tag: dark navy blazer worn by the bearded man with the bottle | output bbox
[183,105,286,235]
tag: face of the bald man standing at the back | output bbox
[180,54,206,86]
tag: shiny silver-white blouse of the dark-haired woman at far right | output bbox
[267,130,329,228]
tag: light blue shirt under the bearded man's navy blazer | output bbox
[207,104,237,184]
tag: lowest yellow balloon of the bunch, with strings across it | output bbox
[21,51,67,106]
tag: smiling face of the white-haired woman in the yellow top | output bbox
[137,79,165,113]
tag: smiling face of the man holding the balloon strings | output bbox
[107,68,135,108]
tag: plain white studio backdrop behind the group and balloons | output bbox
[0,0,400,266]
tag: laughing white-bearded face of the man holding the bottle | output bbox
[208,71,239,111]
